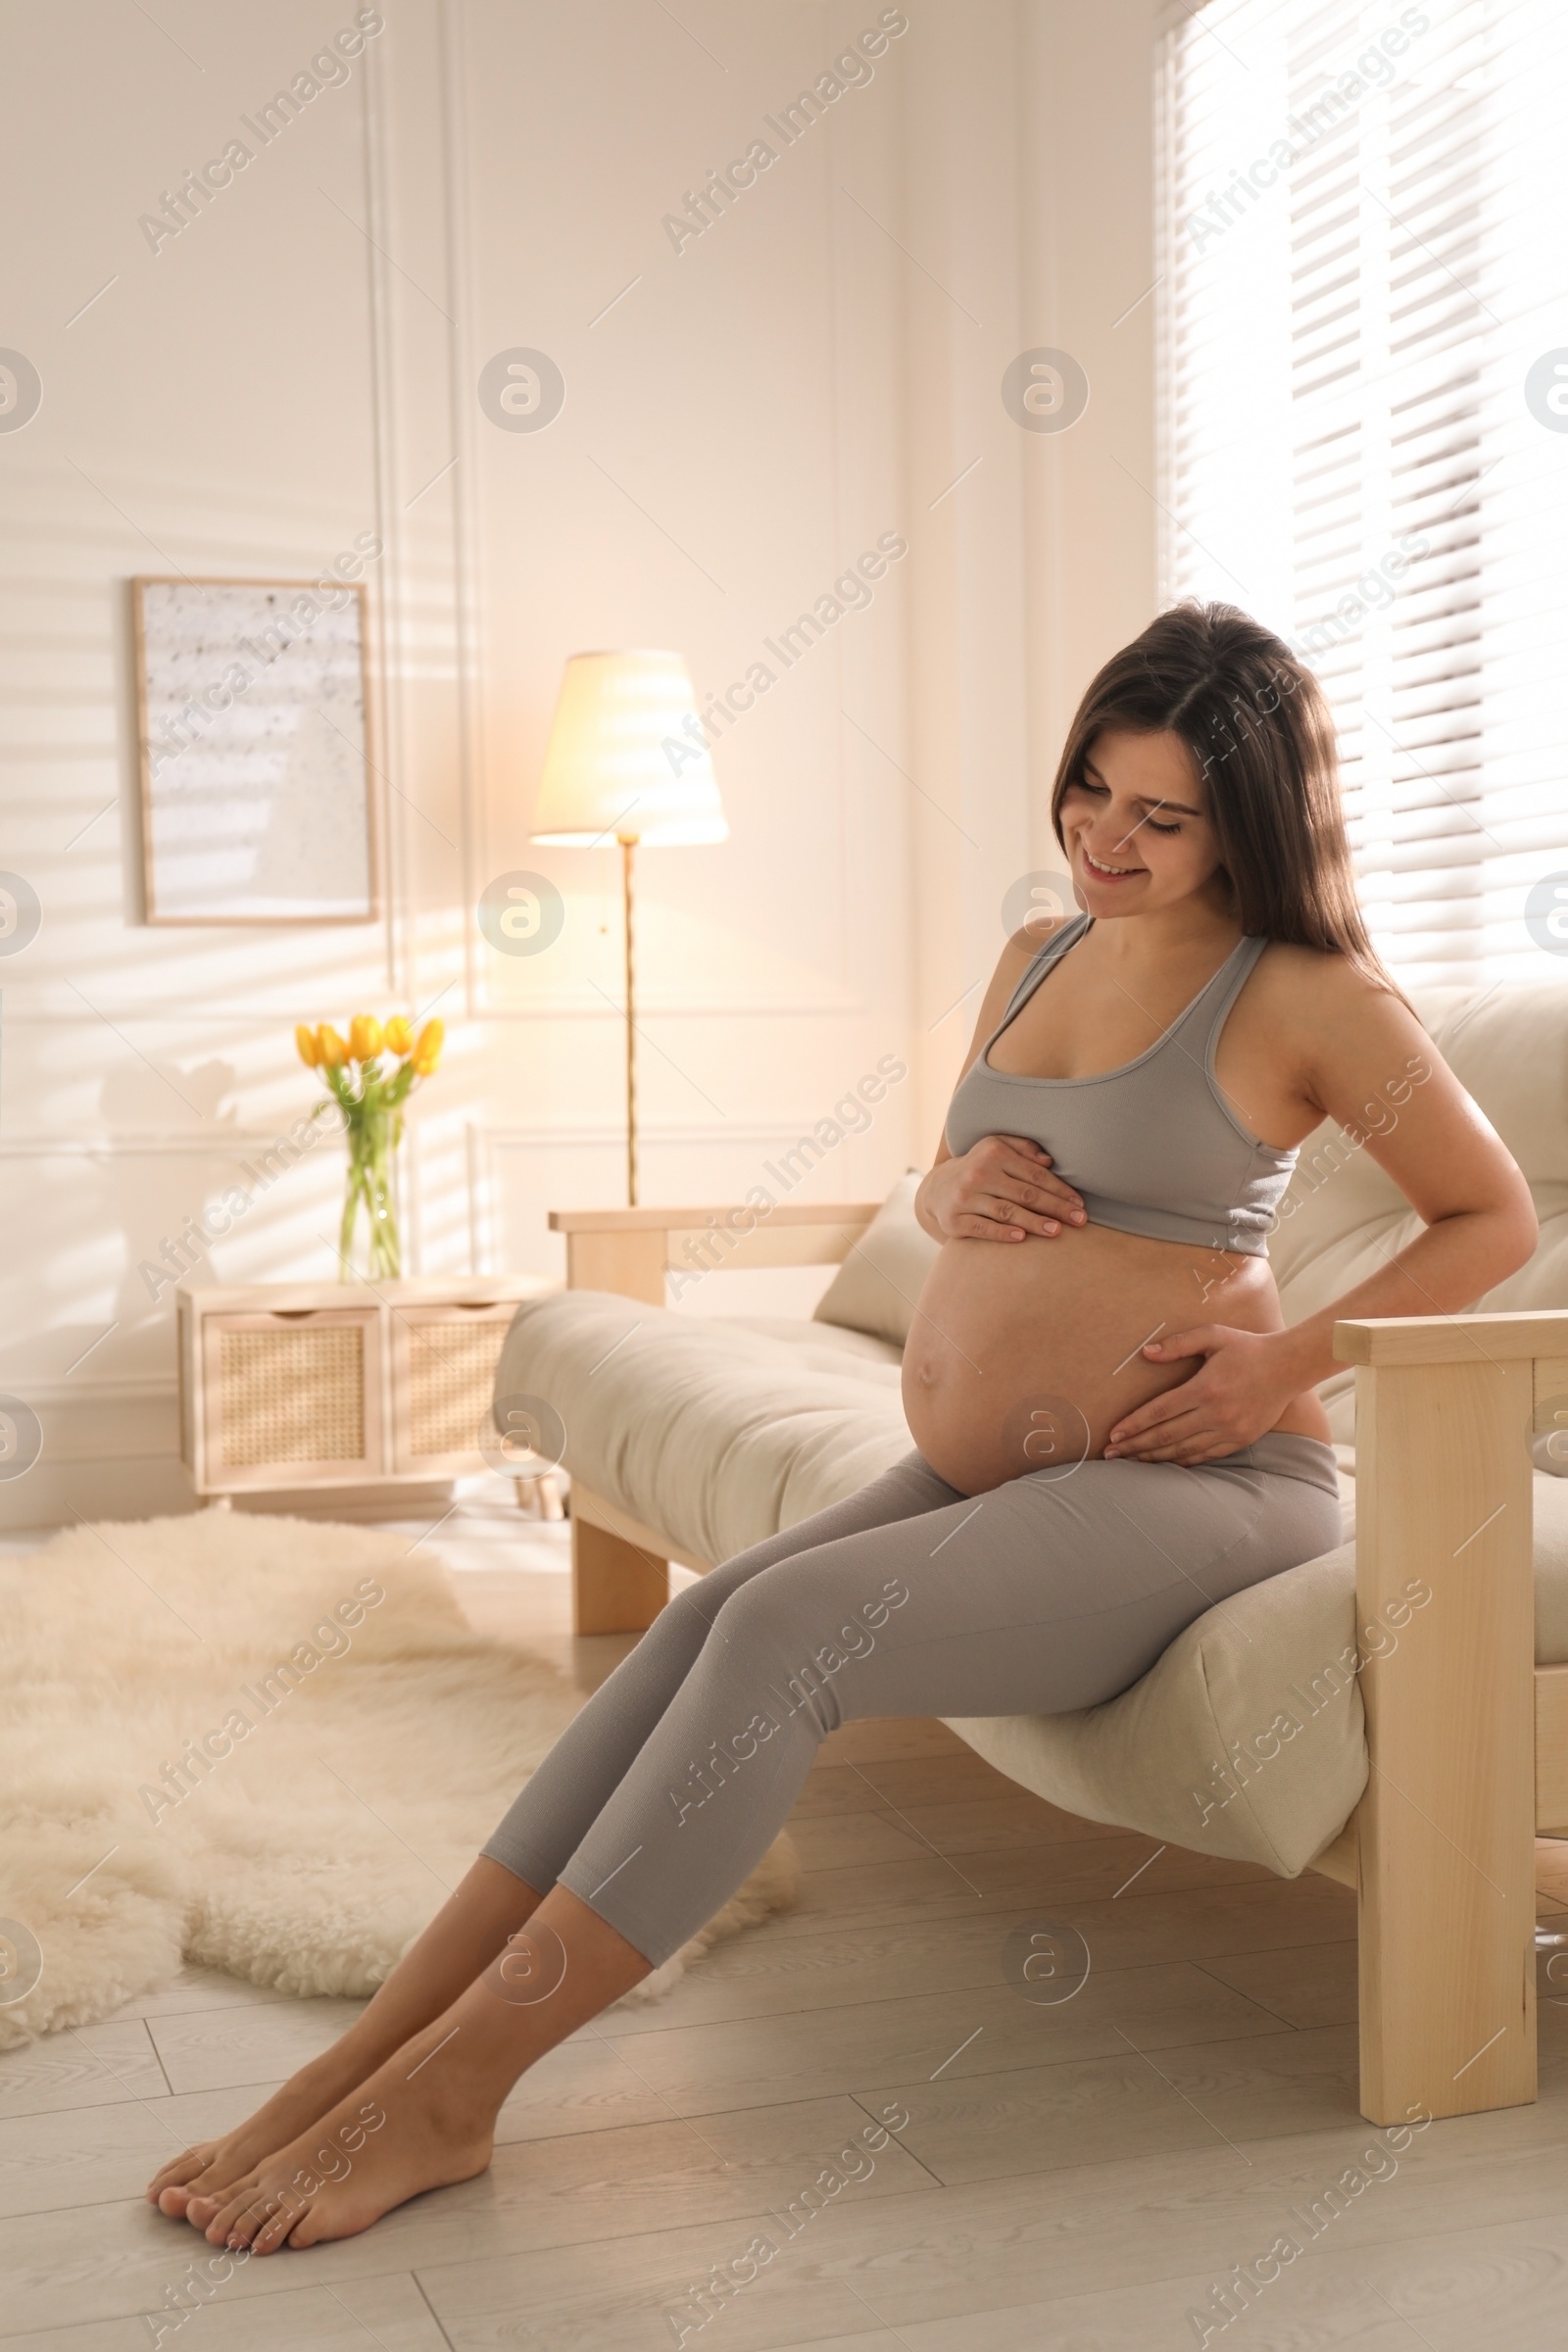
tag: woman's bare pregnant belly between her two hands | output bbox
[903,1225,1328,1494]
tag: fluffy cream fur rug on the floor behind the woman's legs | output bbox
[0,1512,795,2048]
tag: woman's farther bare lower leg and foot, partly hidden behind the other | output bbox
[148,1860,538,2228]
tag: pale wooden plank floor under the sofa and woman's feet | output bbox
[0,1519,1568,2352]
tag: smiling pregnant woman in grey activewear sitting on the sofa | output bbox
[148,607,1535,2253]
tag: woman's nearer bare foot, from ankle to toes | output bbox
[188,2023,494,2253]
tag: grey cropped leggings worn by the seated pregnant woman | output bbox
[484,1435,1340,1966]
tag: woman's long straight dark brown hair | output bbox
[1051,602,1401,995]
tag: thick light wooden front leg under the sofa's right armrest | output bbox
[1356,1336,1535,2124]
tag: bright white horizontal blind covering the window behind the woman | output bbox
[1156,0,1568,986]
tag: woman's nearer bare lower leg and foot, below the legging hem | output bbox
[190,1886,649,2253]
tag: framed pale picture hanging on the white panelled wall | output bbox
[131,578,376,922]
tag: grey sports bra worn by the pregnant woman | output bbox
[948,915,1296,1258]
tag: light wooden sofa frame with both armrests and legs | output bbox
[550,1201,1568,2124]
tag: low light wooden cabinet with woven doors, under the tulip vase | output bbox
[174,1275,560,1515]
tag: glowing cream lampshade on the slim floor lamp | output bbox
[534,652,729,849]
